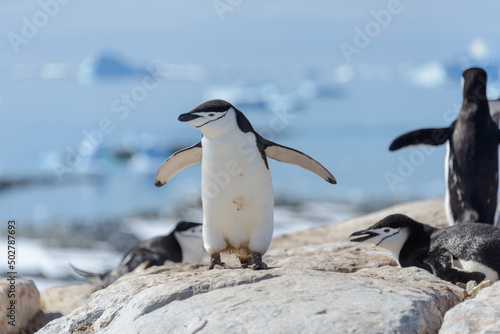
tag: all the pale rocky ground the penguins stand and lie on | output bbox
[31,200,500,334]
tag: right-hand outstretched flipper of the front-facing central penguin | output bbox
[259,137,337,184]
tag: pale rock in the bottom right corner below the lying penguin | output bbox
[439,281,500,334]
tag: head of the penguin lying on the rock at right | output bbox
[349,214,414,257]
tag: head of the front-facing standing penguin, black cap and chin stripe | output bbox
[178,100,243,138]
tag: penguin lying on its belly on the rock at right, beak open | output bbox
[349,214,500,283]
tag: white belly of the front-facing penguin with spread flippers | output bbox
[202,133,274,254]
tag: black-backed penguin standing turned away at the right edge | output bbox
[389,68,500,225]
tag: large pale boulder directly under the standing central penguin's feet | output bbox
[40,244,463,333]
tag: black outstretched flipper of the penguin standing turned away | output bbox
[389,125,453,151]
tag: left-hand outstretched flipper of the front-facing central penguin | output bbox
[155,141,202,187]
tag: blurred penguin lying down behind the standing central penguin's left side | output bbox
[71,222,204,286]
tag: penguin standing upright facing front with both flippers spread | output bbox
[154,100,336,269]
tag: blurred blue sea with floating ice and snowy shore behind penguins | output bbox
[0,0,500,288]
